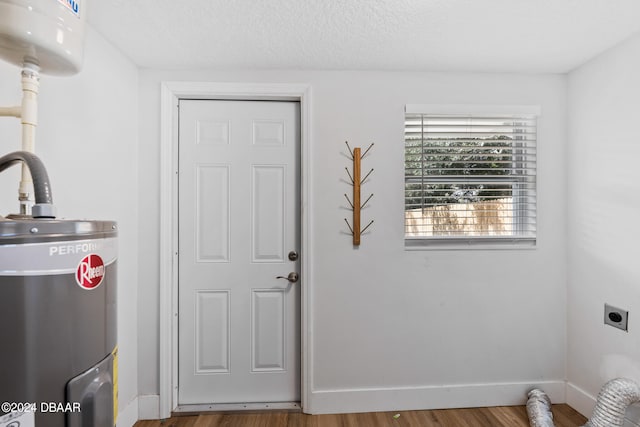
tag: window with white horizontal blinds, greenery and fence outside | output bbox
[404,106,537,247]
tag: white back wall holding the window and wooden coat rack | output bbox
[139,70,566,412]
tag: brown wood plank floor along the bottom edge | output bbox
[134,405,587,427]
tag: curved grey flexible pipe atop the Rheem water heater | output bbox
[0,151,55,218]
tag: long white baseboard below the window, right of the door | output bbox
[303,381,566,414]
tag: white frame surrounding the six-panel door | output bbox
[159,82,313,418]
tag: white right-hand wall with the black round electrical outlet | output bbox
[567,35,640,423]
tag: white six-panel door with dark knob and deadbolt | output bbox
[178,100,300,405]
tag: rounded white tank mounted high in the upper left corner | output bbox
[0,0,86,75]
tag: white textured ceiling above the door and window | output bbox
[88,0,640,72]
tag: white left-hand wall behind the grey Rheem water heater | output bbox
[0,29,139,425]
